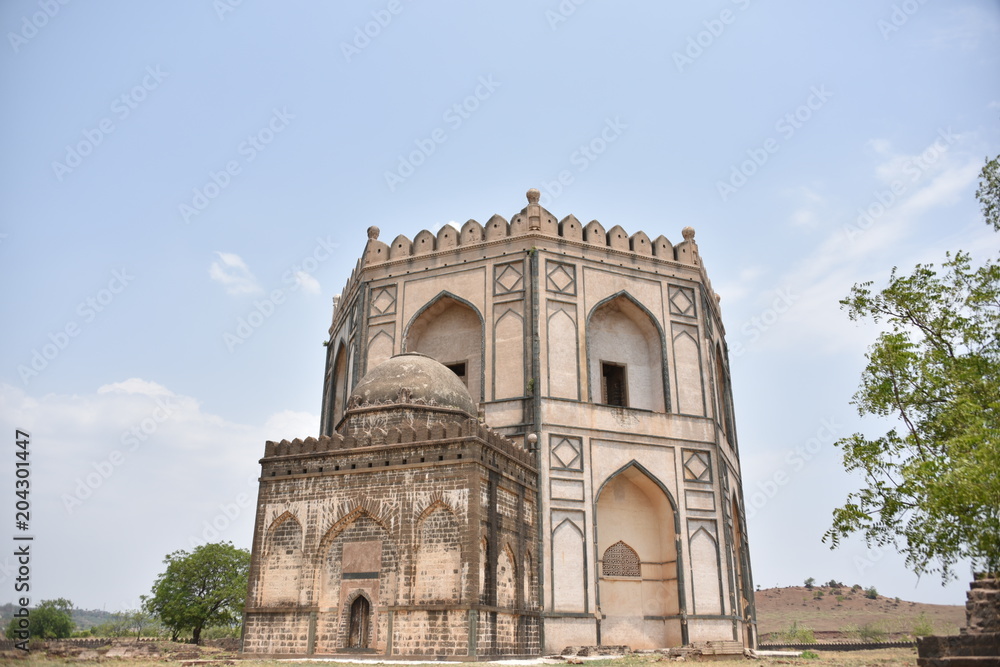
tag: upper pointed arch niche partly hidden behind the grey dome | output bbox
[403,290,486,403]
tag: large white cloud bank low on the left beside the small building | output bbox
[0,378,319,609]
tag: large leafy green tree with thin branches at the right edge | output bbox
[823,158,1000,582]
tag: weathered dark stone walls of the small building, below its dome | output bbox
[244,355,539,658]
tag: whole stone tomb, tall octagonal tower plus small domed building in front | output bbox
[244,190,756,659]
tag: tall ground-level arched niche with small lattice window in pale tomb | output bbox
[597,462,683,648]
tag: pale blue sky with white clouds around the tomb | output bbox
[0,0,1000,610]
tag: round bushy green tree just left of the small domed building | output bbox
[144,542,250,644]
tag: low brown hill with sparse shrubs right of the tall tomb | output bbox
[756,586,965,642]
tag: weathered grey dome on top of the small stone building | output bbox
[351,352,478,417]
